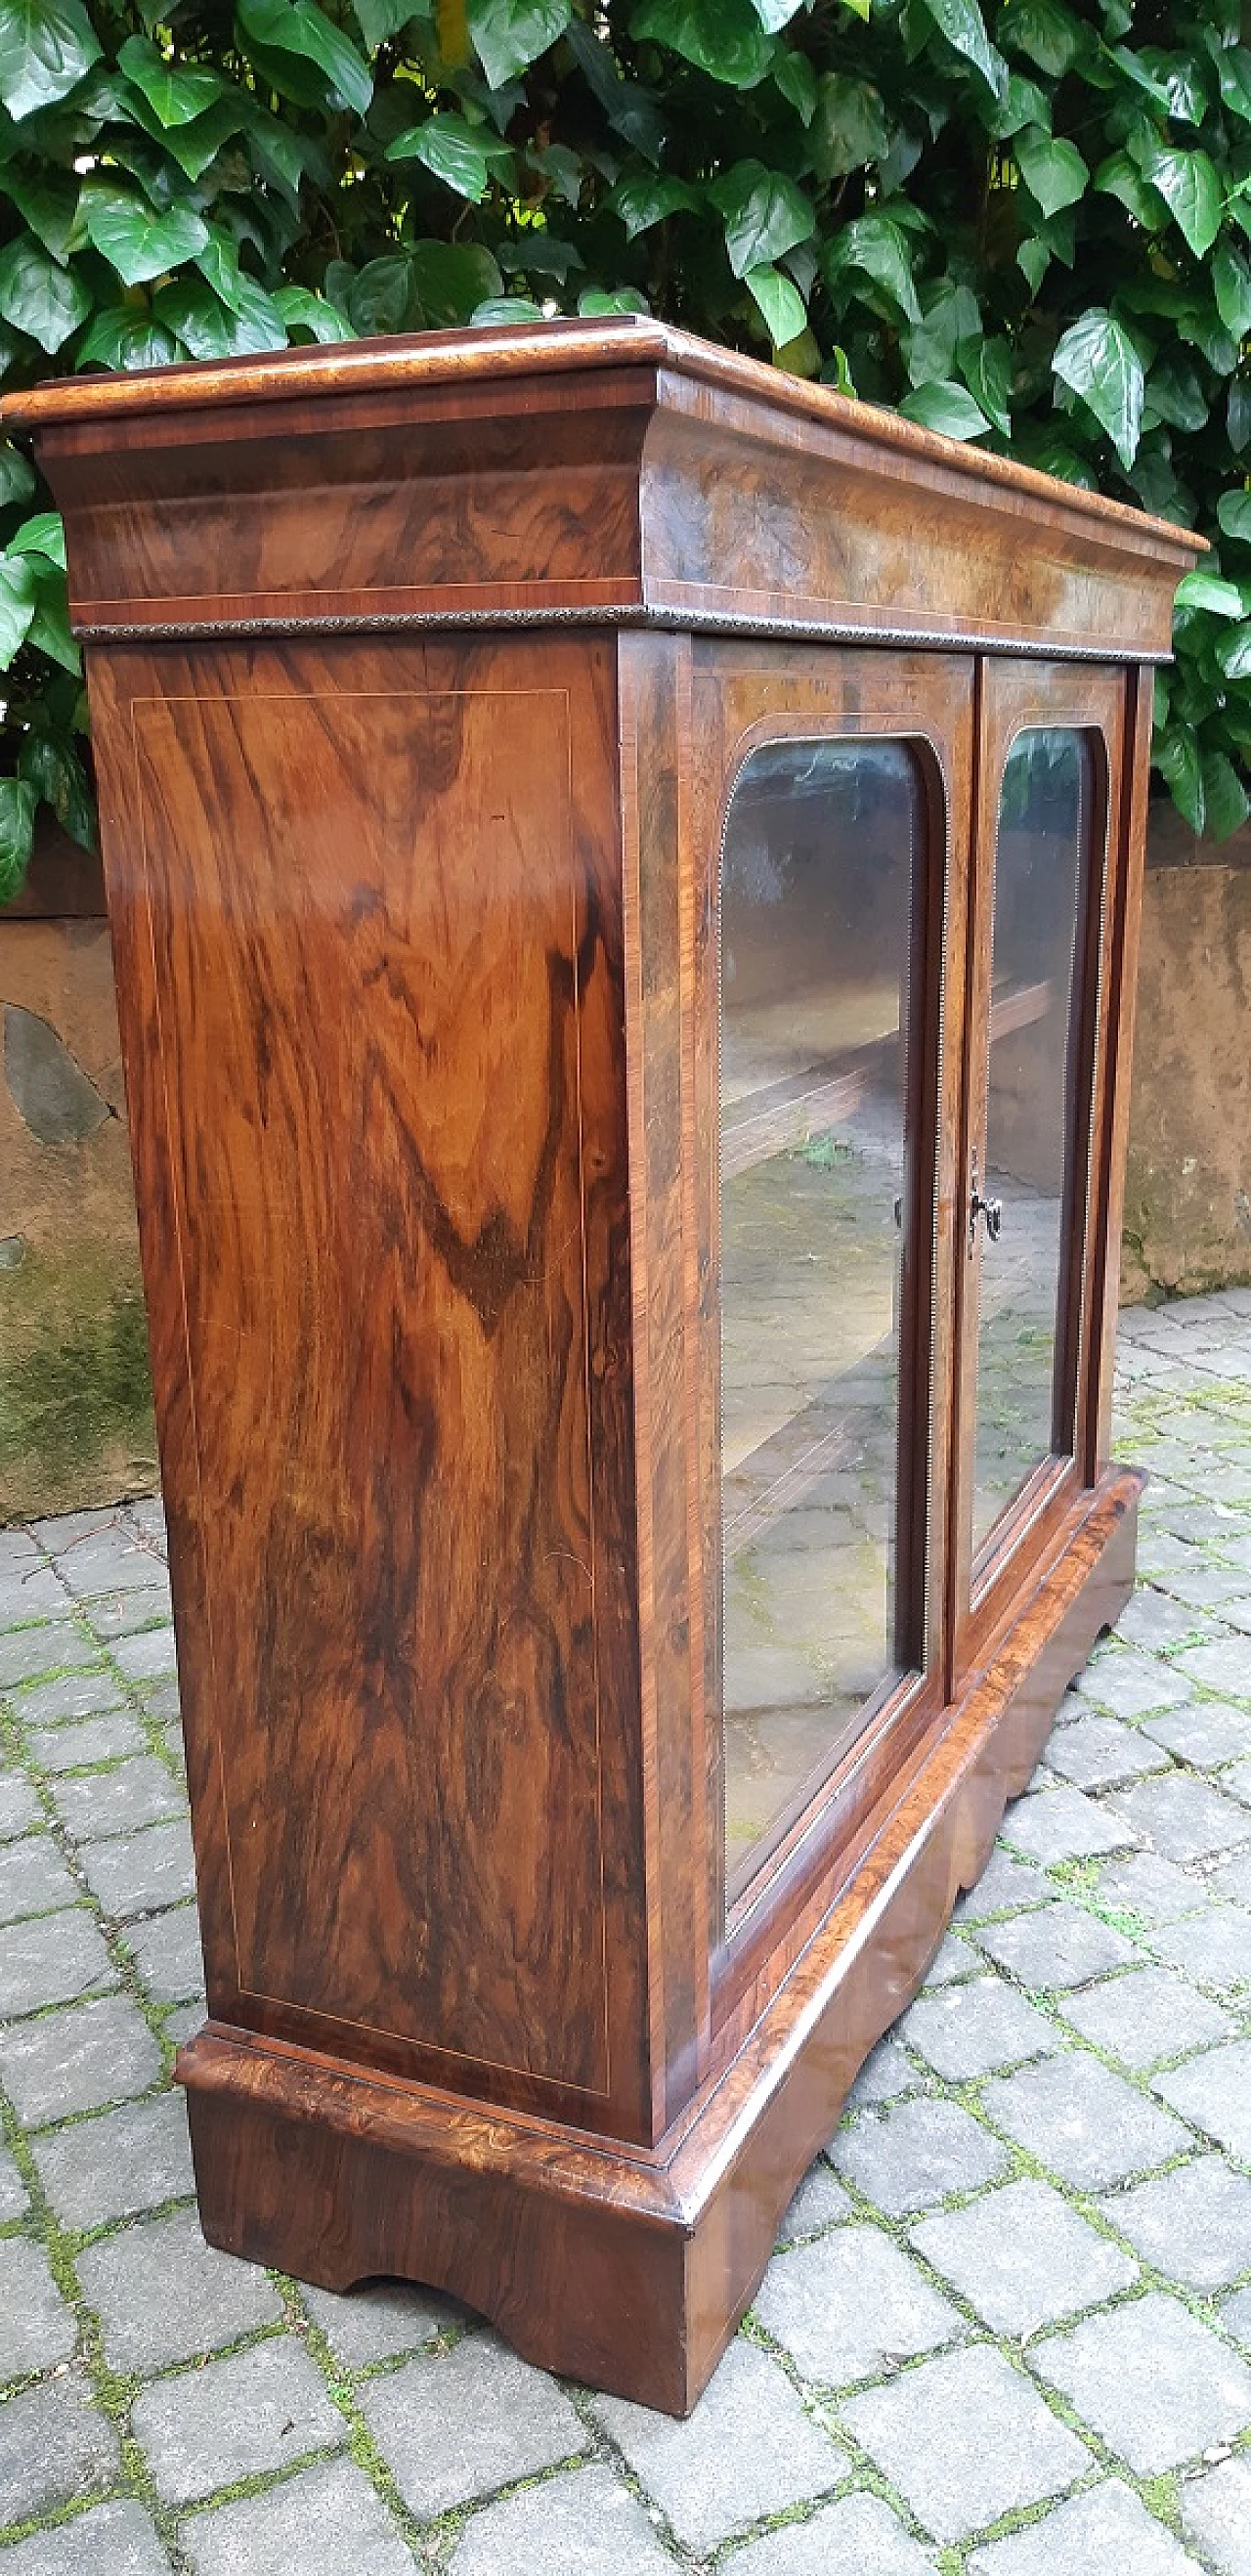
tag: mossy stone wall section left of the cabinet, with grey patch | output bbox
[0,835,157,1522]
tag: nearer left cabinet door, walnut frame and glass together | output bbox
[692,646,973,1991]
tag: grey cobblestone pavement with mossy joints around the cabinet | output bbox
[0,1290,1251,2576]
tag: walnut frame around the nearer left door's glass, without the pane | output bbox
[685,646,973,2028]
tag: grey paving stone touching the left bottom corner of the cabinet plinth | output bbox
[77,2210,283,2370]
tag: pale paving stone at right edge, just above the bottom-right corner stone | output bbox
[1029,2291,1251,2478]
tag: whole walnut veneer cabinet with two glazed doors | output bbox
[5,320,1199,2414]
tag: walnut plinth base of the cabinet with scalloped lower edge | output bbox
[178,1471,1141,2414]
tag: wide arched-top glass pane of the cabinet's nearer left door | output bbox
[720,739,927,1896]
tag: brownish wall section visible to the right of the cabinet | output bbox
[1120,808,1251,1306]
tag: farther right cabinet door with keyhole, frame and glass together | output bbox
[950,662,1125,1687]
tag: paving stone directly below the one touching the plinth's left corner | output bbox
[131,2334,348,2504]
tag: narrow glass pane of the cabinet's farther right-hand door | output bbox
[973,729,1094,1549]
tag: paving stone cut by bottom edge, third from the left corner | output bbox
[451,2467,674,2576]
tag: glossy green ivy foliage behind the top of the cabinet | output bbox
[0,0,1251,894]
